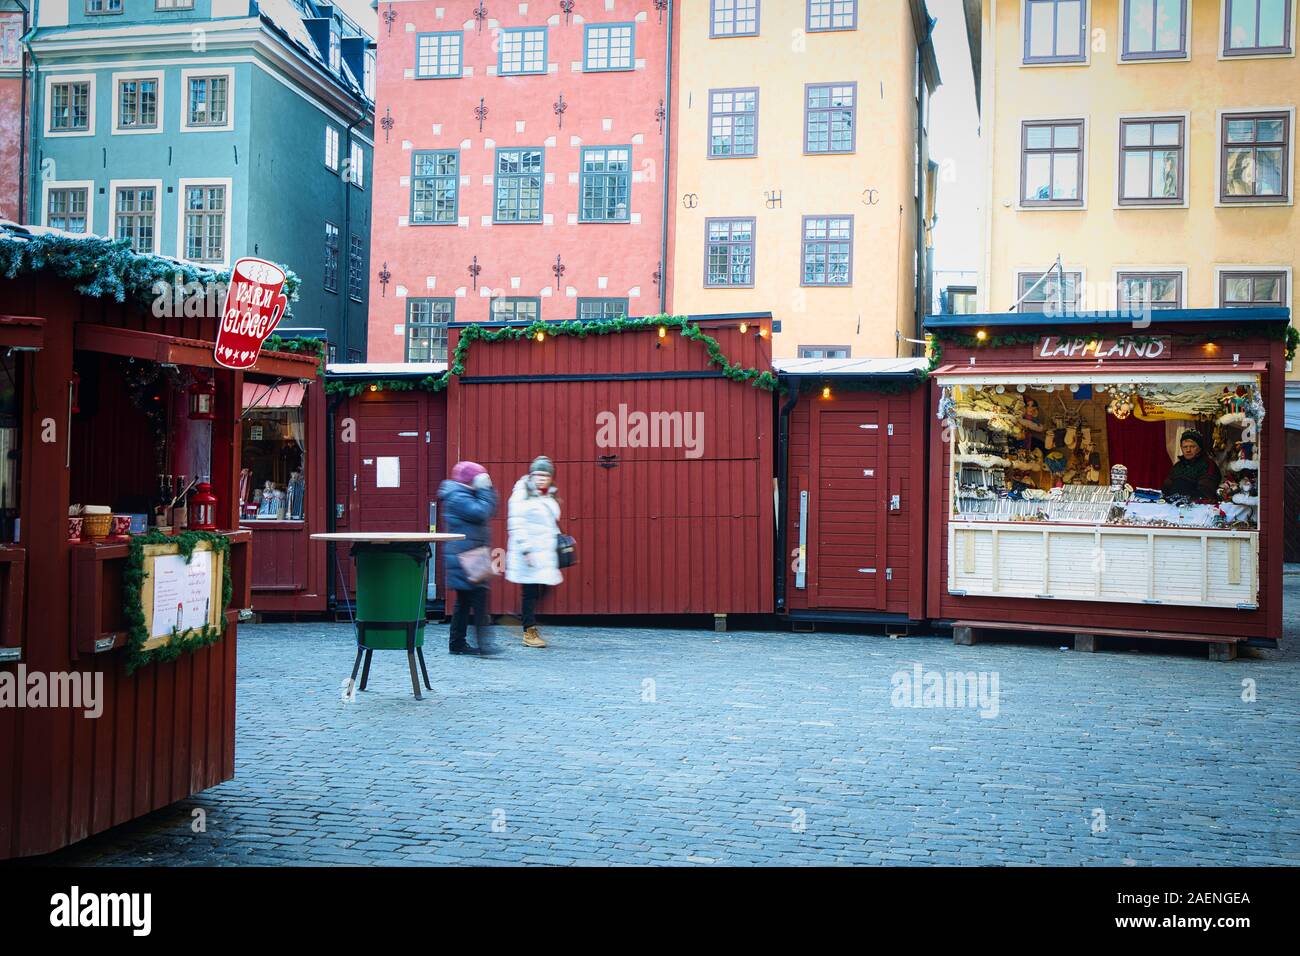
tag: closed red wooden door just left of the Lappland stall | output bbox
[807,406,889,610]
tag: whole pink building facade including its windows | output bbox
[368,0,672,362]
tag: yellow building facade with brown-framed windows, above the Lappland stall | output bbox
[979,0,1300,340]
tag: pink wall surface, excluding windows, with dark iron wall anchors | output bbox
[368,0,668,362]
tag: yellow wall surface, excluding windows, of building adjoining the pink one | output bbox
[671,0,917,358]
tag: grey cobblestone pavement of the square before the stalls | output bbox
[20,575,1300,865]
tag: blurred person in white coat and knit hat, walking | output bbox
[506,455,564,648]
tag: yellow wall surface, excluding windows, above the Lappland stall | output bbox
[979,0,1300,335]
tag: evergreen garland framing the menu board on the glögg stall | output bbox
[122,529,234,674]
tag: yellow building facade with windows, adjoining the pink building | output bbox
[668,0,939,358]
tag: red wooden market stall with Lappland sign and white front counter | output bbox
[926,308,1295,659]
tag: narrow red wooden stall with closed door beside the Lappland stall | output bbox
[775,359,928,627]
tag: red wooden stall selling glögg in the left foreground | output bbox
[0,228,311,858]
